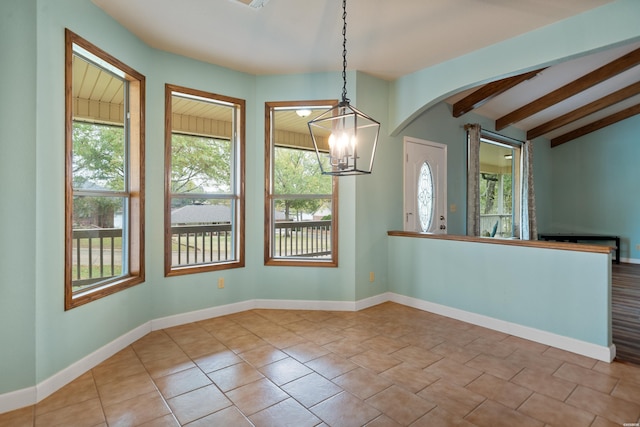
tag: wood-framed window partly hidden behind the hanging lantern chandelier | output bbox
[264,101,338,267]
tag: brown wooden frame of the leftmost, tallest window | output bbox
[64,29,146,310]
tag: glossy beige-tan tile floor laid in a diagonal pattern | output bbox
[0,303,640,427]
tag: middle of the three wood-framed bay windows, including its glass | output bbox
[165,85,245,276]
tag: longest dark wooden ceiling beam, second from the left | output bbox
[496,48,640,130]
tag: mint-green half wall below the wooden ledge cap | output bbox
[389,236,611,355]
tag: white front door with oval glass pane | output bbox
[404,137,447,234]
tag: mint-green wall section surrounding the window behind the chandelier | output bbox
[247,73,355,301]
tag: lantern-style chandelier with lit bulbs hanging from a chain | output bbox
[308,0,380,176]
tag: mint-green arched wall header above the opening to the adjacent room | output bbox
[389,0,640,135]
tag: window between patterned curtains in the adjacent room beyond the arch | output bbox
[478,135,521,238]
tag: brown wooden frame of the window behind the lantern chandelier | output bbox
[264,100,339,267]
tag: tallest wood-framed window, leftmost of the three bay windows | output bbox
[65,30,145,310]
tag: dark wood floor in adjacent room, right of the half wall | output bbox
[611,263,640,366]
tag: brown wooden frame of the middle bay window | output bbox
[164,83,246,277]
